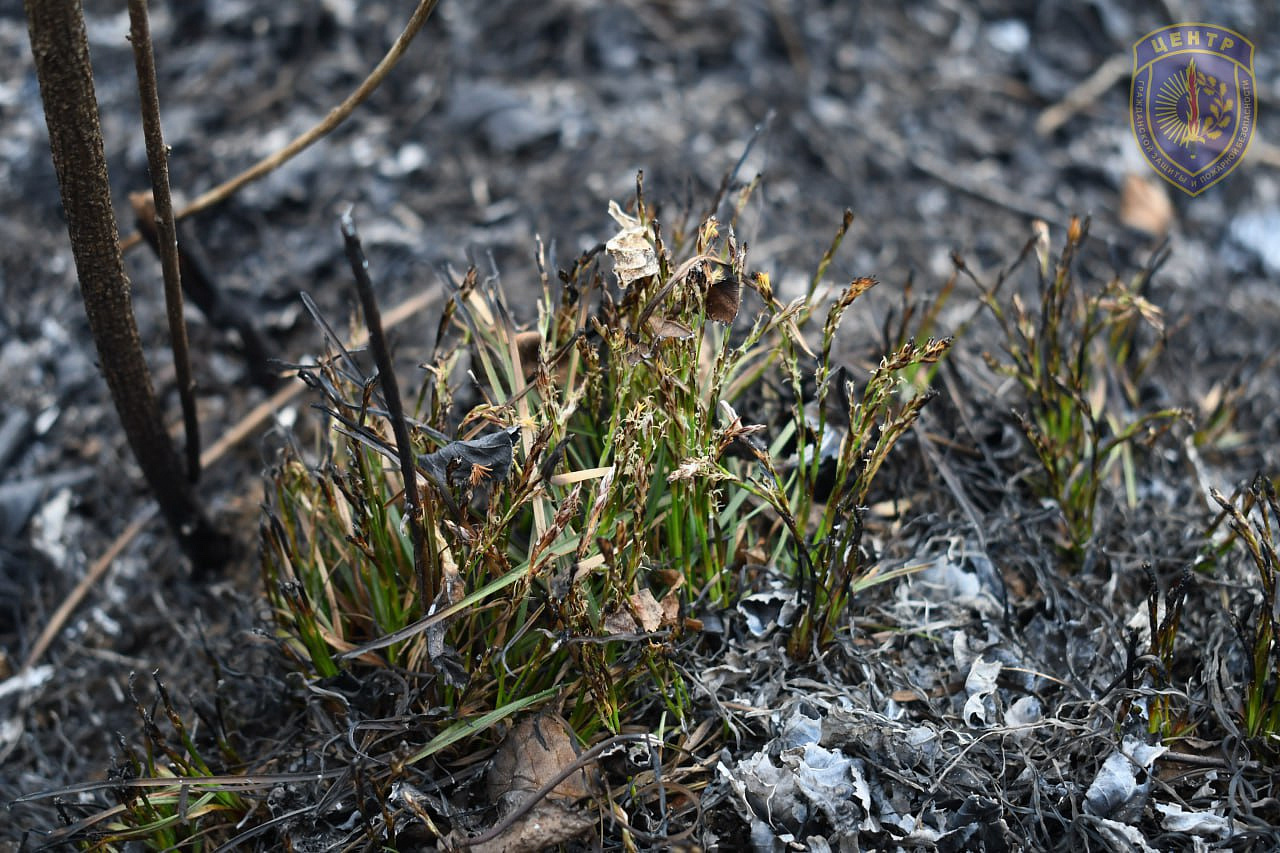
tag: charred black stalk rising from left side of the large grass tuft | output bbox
[340,210,435,604]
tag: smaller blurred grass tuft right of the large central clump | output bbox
[956,218,1188,555]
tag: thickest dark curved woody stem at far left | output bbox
[24,0,229,570]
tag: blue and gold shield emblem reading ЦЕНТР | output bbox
[1129,23,1257,196]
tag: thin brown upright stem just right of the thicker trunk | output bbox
[129,0,200,483]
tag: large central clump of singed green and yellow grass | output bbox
[252,178,950,829]
